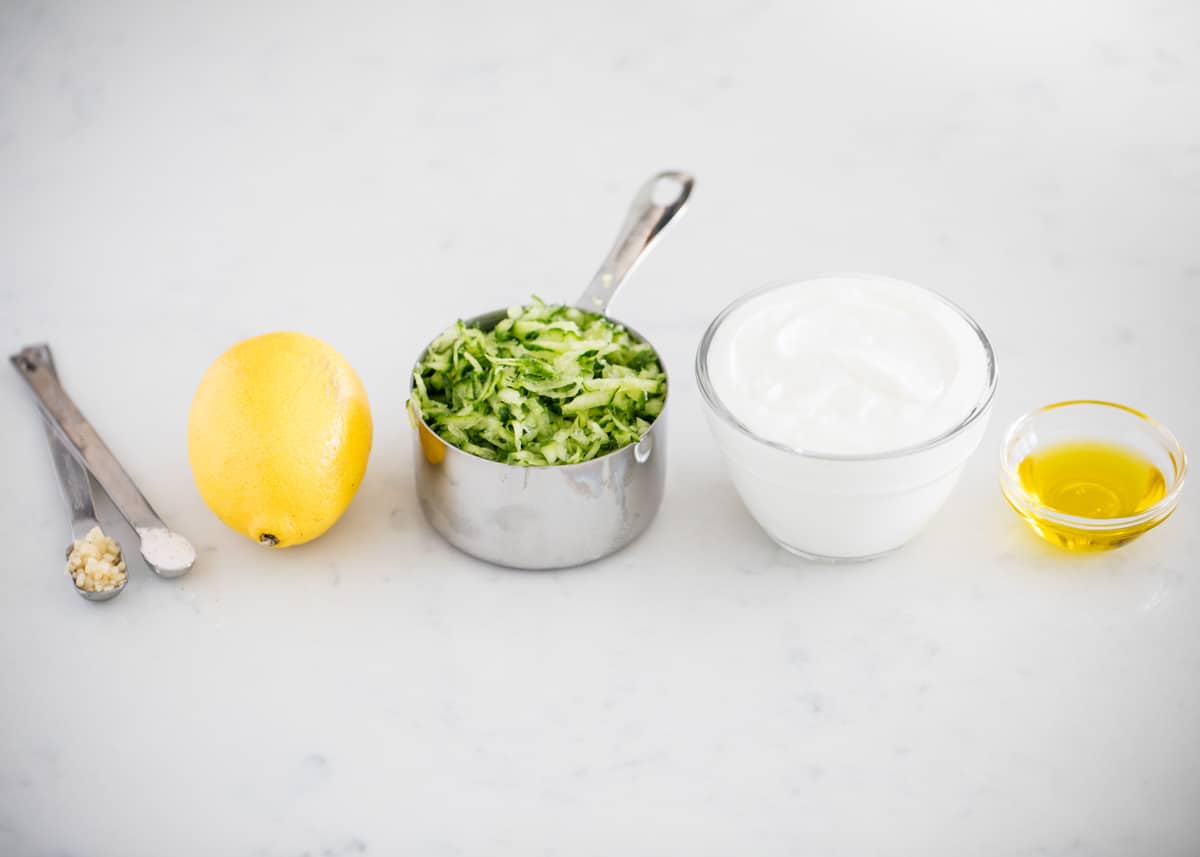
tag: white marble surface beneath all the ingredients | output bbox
[0,0,1200,857]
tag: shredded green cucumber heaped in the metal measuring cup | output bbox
[413,298,666,467]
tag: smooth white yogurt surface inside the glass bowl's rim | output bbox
[708,277,988,455]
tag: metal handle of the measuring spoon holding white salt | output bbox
[10,346,166,529]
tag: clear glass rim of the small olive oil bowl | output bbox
[1000,398,1188,533]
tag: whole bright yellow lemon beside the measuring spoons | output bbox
[187,332,371,547]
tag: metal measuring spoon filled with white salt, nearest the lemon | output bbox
[10,346,196,577]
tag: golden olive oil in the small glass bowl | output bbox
[1016,441,1166,551]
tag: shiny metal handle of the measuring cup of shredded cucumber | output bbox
[575,170,696,312]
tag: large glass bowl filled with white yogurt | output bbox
[696,275,996,559]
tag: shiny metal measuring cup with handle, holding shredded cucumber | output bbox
[409,172,695,569]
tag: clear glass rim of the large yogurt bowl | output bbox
[695,271,998,461]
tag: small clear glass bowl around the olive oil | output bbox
[1000,400,1188,551]
